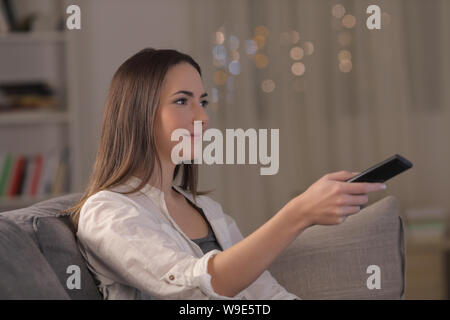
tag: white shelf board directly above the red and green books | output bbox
[0,111,69,126]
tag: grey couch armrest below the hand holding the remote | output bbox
[269,196,405,299]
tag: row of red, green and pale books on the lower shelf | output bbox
[0,148,69,201]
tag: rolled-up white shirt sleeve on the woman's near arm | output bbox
[77,192,243,300]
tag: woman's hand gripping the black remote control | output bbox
[285,171,385,227]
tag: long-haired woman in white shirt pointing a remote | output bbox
[66,48,382,299]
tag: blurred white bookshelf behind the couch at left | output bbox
[0,31,79,212]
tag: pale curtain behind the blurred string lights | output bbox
[190,0,450,234]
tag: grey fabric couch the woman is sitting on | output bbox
[0,193,405,299]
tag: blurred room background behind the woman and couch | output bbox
[0,0,450,299]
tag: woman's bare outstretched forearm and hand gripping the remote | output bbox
[208,171,382,297]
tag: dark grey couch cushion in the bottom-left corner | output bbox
[0,218,69,299]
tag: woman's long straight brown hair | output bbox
[63,48,207,230]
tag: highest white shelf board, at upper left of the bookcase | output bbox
[0,31,66,45]
